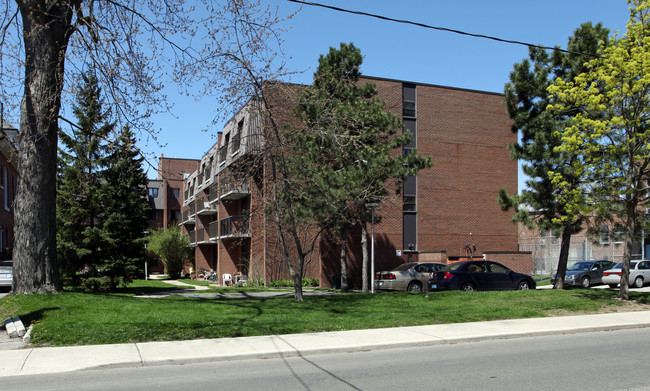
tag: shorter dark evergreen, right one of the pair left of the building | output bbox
[101,127,151,288]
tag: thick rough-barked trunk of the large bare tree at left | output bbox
[13,1,72,293]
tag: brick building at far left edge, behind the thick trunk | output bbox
[0,120,18,260]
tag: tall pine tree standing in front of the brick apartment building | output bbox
[285,43,432,291]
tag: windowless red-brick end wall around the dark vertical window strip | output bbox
[362,80,518,254]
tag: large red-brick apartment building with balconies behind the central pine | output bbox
[181,77,532,286]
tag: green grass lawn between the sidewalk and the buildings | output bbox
[0,281,650,346]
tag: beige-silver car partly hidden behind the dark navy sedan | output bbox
[375,262,446,292]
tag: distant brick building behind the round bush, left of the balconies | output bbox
[147,155,200,272]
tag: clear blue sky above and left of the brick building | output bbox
[140,0,629,188]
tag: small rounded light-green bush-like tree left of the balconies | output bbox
[147,227,192,279]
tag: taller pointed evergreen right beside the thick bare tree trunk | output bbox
[57,72,115,284]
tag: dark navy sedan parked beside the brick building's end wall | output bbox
[427,260,536,291]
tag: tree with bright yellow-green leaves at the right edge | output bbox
[547,0,650,300]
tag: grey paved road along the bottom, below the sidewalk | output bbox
[2,328,650,391]
